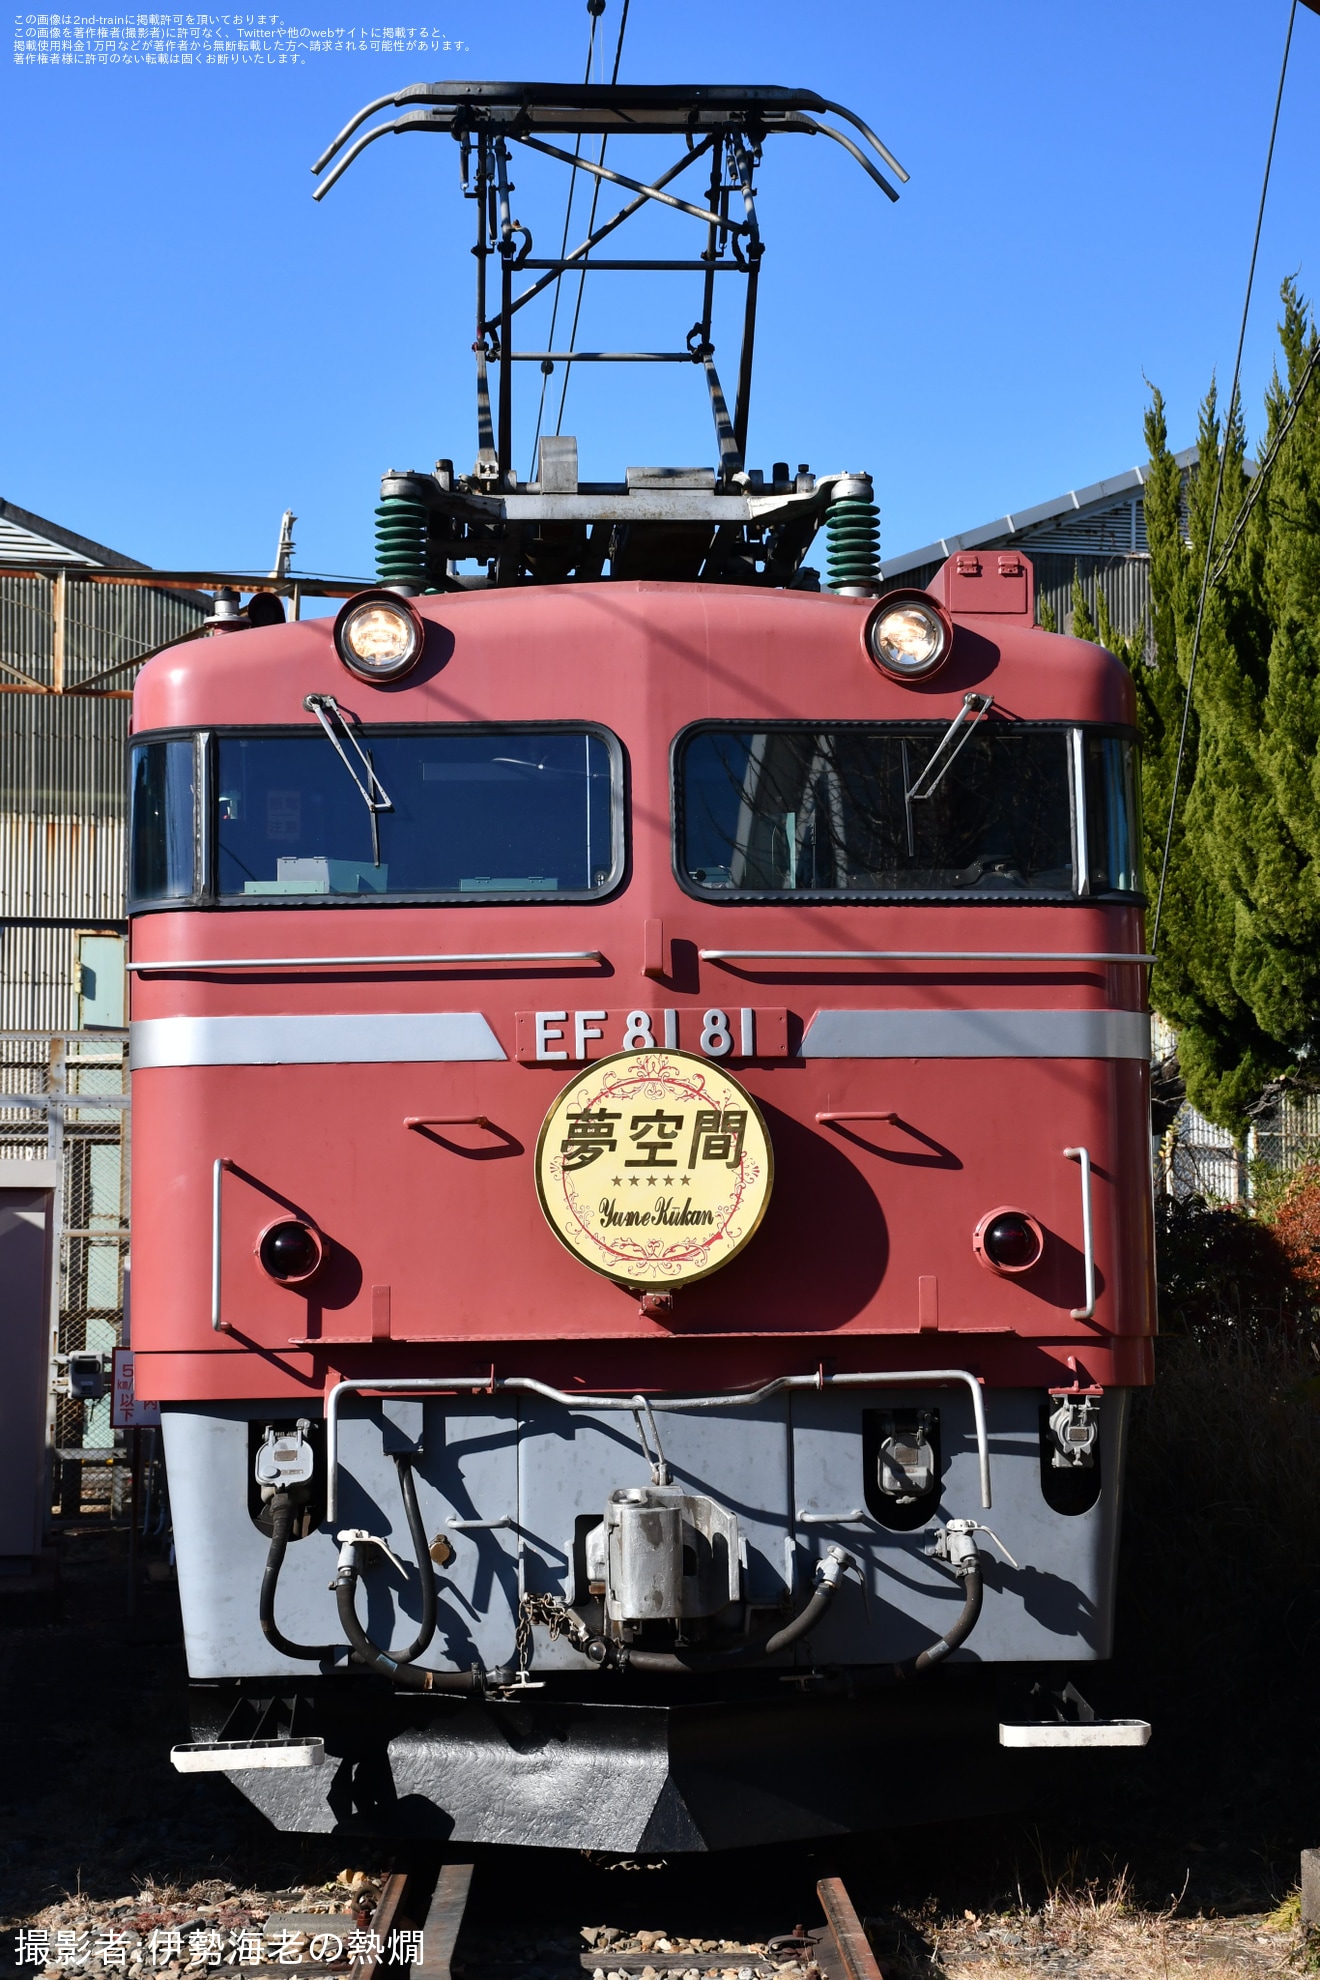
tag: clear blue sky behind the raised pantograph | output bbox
[0,0,1320,574]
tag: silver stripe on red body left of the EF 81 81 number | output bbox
[129,1010,507,1073]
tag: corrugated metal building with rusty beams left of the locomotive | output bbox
[0,501,210,1515]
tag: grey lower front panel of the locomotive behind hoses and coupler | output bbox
[162,1386,1126,1679]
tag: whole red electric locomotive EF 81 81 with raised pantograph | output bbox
[131,83,1152,1851]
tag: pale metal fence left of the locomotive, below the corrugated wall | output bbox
[0,1030,129,1515]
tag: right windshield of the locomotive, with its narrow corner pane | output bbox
[677,728,1140,895]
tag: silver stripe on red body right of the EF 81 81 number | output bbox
[801,1010,1150,1059]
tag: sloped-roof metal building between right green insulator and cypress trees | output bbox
[883,447,1197,636]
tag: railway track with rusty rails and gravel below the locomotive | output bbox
[356,1863,883,1980]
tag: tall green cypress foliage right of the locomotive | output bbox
[1124,283,1320,1133]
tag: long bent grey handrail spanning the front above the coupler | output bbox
[325,1368,990,1527]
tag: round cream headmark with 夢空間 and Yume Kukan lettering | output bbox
[536,1051,774,1287]
